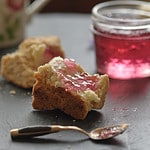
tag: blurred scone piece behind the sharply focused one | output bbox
[1,36,64,88]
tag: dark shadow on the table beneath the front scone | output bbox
[29,110,103,131]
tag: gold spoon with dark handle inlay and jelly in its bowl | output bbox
[10,124,128,140]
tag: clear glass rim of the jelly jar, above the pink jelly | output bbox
[92,0,150,32]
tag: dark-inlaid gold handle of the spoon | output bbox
[10,125,62,139]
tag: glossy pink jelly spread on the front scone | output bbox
[58,58,99,91]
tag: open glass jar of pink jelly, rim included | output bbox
[92,0,150,79]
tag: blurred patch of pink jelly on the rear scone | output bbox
[44,46,63,62]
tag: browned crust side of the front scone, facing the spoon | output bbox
[32,84,88,119]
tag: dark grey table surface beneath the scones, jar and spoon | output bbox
[0,14,150,150]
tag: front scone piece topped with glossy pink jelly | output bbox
[32,57,109,119]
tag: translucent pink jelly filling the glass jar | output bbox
[94,28,150,79]
